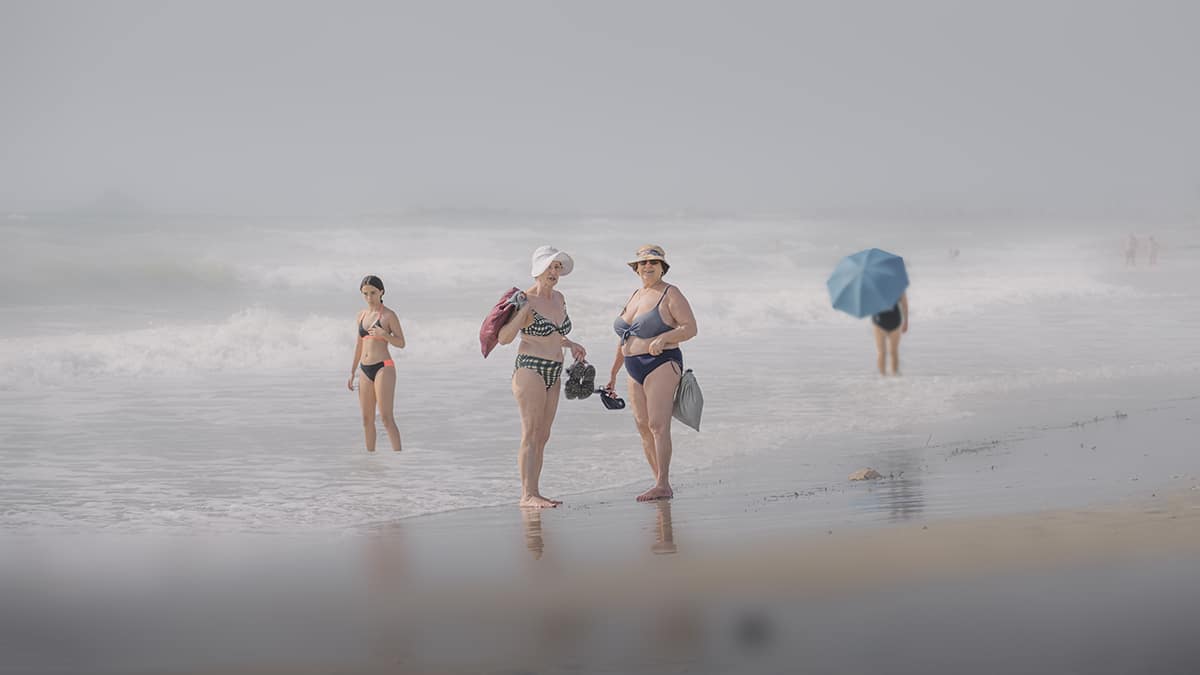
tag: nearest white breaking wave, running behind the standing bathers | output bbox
[0,269,1161,382]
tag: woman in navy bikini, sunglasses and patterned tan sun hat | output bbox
[606,245,696,502]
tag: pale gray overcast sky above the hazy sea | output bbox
[0,0,1200,213]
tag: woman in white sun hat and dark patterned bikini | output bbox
[499,246,587,508]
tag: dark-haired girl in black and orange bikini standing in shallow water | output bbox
[346,274,404,453]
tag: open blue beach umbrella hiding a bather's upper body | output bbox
[826,249,908,318]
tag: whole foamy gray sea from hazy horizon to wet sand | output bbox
[0,212,1200,534]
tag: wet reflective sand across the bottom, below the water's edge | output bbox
[7,399,1200,674]
